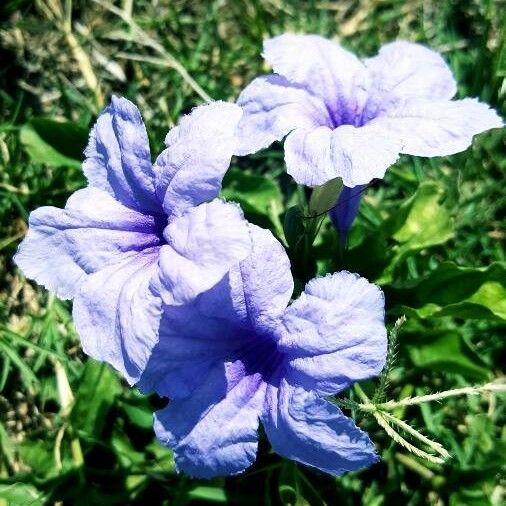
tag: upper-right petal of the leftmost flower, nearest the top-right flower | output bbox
[155,102,242,219]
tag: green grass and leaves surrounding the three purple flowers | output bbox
[0,0,506,506]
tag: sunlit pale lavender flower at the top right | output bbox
[236,34,502,187]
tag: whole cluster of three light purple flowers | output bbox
[15,35,502,477]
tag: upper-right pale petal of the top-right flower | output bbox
[364,40,457,119]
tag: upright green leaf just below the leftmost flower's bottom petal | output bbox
[70,360,120,436]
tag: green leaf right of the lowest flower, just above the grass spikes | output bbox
[408,331,489,381]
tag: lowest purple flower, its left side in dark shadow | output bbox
[139,226,387,478]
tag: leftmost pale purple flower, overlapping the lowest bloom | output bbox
[15,97,251,383]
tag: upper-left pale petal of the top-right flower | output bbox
[263,33,369,126]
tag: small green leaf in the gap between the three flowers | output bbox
[221,169,282,215]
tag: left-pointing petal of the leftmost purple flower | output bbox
[14,188,160,298]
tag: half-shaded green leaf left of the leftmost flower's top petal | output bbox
[19,118,88,168]
